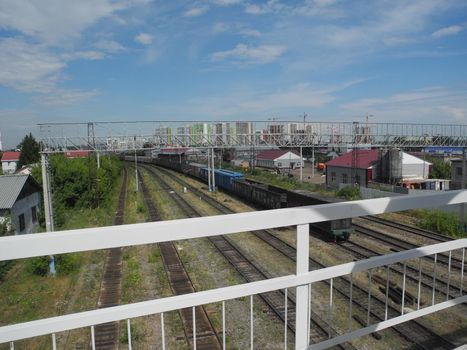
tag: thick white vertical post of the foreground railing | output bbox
[295,224,310,349]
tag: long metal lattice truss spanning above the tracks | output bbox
[38,121,467,153]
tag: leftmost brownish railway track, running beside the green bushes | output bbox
[94,167,128,350]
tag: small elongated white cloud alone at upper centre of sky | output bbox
[211,44,286,64]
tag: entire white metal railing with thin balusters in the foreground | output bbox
[0,191,467,349]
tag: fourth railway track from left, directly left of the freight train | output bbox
[152,167,455,350]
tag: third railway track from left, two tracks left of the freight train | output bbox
[143,166,355,349]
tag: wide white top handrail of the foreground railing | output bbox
[0,190,467,261]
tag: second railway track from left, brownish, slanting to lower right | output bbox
[138,173,222,350]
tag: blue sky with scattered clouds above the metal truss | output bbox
[0,0,467,148]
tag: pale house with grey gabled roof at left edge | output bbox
[0,175,41,234]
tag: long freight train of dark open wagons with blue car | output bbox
[130,157,353,240]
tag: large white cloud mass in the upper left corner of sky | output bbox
[0,0,147,105]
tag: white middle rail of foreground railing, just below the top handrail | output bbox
[0,238,467,343]
